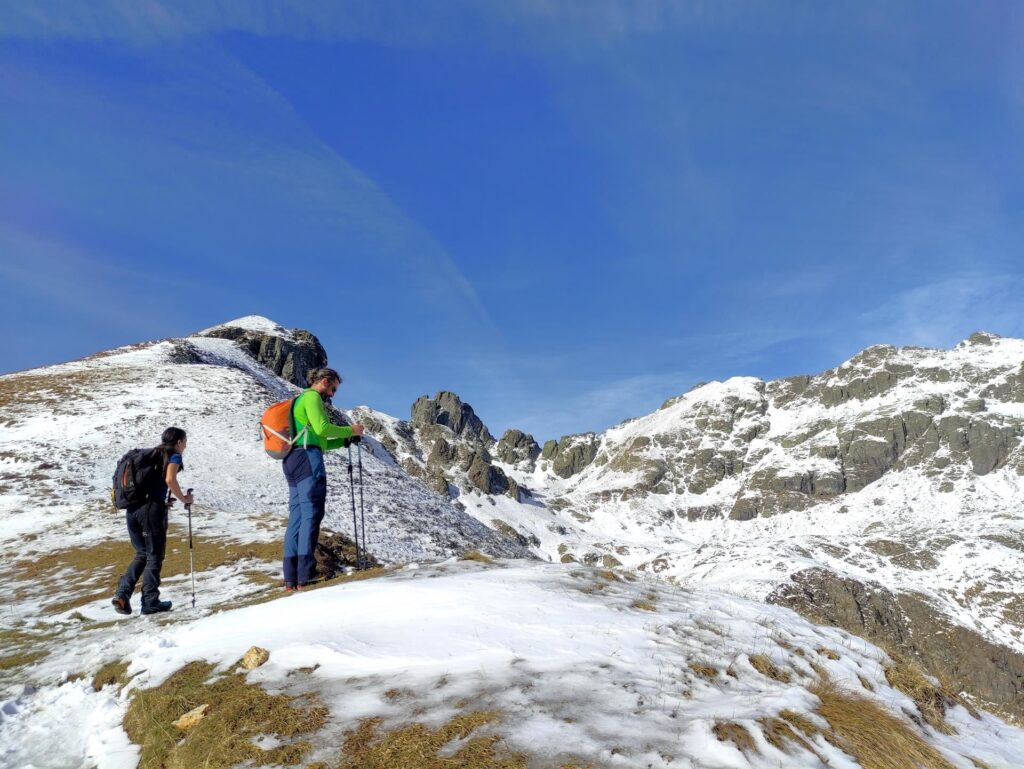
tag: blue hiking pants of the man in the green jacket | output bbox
[284,447,327,585]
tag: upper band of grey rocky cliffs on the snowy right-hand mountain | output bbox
[541,333,1024,520]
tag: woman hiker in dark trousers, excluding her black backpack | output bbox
[111,427,193,614]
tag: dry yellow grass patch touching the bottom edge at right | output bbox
[811,679,954,769]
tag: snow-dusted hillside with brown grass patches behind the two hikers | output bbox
[0,318,527,651]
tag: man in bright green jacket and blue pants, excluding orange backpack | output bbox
[284,368,364,591]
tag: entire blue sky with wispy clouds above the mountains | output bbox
[0,0,1024,440]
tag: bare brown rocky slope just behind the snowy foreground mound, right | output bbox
[768,568,1024,719]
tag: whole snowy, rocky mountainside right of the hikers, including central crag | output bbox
[346,333,1024,718]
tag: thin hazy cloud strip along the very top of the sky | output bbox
[0,0,874,47]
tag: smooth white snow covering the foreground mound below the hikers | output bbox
[0,560,1024,769]
